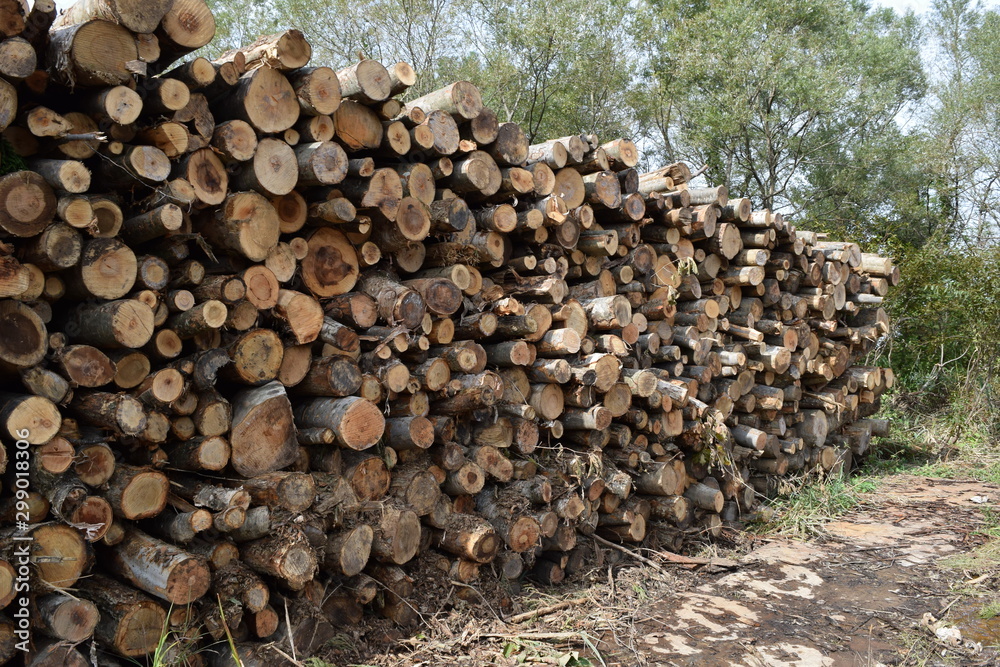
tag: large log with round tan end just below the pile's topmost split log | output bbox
[212,67,299,134]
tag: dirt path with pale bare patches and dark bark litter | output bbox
[620,476,1000,667]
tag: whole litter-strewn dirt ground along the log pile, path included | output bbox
[327,475,1000,667]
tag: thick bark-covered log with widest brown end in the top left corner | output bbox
[47,19,138,87]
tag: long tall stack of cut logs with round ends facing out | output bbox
[0,0,898,665]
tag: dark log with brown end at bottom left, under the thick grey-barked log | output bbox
[79,574,167,658]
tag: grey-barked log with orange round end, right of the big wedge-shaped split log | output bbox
[295,396,385,451]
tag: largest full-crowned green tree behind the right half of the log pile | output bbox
[640,0,924,235]
